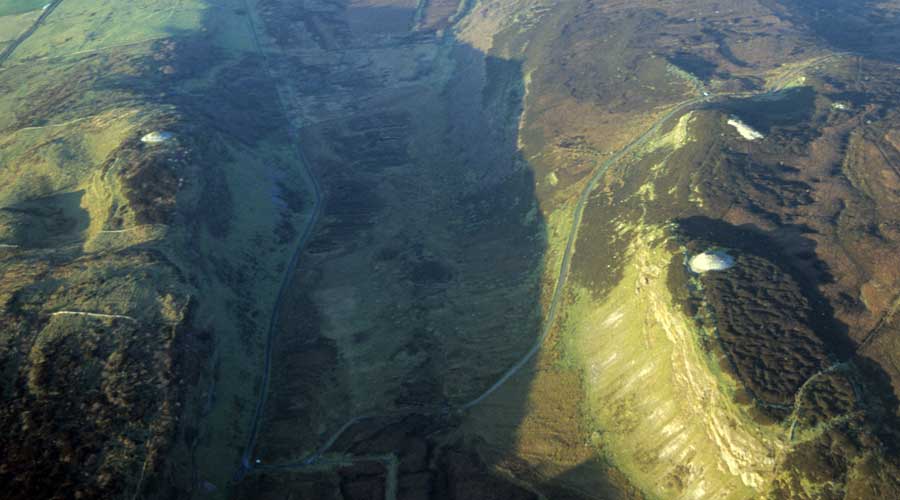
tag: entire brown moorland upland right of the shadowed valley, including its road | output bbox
[461,1,898,498]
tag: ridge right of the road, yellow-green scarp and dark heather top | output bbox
[562,83,896,498]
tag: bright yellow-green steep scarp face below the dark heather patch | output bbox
[575,229,784,498]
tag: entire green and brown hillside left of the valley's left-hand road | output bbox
[0,0,312,498]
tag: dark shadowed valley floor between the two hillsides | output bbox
[203,1,624,500]
